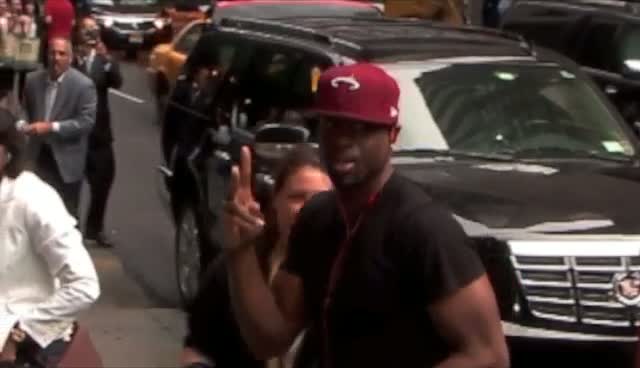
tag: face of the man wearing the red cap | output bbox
[320,117,392,189]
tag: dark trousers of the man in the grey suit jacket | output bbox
[36,144,82,219]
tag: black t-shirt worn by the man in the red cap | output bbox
[284,174,484,368]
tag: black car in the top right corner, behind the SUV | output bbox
[501,0,640,134]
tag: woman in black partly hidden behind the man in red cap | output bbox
[182,148,331,368]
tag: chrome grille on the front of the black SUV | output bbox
[511,255,640,327]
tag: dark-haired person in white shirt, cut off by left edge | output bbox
[0,110,100,368]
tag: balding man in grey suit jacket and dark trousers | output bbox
[18,38,97,218]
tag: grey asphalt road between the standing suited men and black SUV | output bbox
[106,57,179,307]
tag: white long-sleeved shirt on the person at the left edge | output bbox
[0,171,100,347]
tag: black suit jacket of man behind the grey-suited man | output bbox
[73,55,122,149]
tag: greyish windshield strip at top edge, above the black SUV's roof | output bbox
[215,3,381,21]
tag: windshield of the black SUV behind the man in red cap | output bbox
[380,64,635,158]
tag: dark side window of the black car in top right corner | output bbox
[578,17,620,73]
